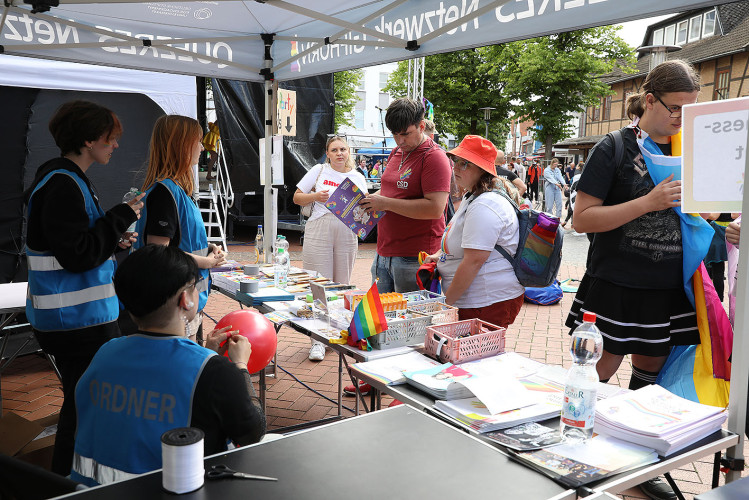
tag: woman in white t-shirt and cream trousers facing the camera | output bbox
[294,135,367,361]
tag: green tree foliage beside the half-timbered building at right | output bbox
[491,26,635,159]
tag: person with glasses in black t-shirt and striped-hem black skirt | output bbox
[566,60,700,499]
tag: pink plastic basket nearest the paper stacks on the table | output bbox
[424,319,505,363]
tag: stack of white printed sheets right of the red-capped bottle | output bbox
[595,385,728,456]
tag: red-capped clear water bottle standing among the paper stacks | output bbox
[560,312,603,442]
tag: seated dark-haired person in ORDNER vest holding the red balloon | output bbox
[71,245,265,485]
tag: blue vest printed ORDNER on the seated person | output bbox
[71,334,216,486]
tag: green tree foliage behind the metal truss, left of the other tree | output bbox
[384,46,512,148]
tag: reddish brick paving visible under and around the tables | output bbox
[2,231,744,499]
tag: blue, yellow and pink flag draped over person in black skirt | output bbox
[637,128,733,407]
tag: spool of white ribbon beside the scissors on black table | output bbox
[161,427,205,494]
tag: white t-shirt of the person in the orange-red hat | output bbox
[437,192,525,308]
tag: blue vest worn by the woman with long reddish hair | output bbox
[133,179,211,311]
